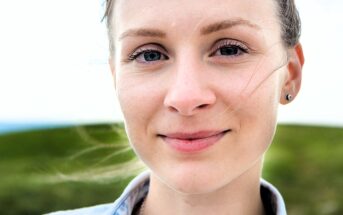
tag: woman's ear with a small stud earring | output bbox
[280,43,305,104]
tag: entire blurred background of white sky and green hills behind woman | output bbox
[0,0,343,215]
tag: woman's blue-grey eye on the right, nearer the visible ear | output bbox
[210,39,249,57]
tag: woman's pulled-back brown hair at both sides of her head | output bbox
[103,0,301,56]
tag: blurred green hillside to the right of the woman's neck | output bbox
[263,126,343,215]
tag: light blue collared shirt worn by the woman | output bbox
[49,171,287,215]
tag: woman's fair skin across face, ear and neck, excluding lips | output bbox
[110,0,304,215]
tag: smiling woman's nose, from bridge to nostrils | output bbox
[164,58,216,116]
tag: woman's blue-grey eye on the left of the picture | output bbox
[129,45,169,63]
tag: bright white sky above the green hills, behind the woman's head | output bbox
[0,0,343,126]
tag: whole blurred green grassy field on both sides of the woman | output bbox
[0,124,343,215]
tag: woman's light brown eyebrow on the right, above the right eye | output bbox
[200,19,261,35]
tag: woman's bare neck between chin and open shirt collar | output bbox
[144,161,264,215]
